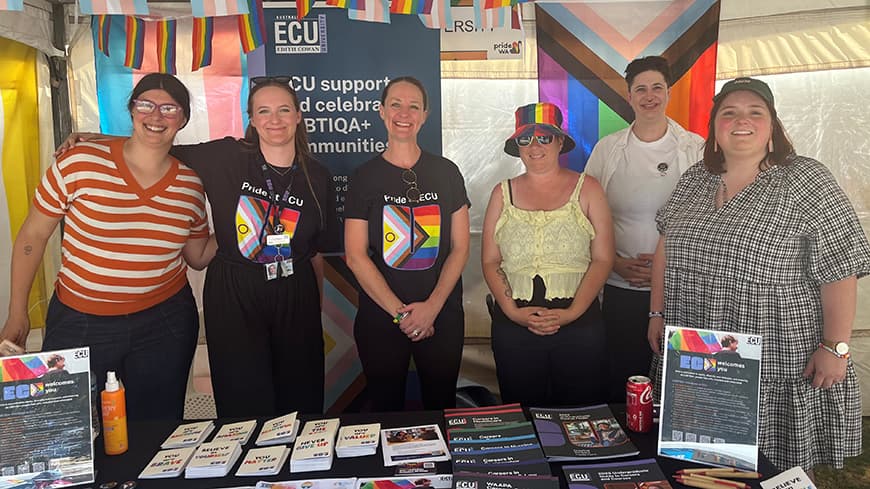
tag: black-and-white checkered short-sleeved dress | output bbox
[653,156,870,469]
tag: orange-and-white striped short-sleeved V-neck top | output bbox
[33,139,209,316]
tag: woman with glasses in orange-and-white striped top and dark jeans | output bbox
[0,73,215,419]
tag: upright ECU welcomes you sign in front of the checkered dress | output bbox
[658,326,762,471]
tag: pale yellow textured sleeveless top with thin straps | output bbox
[495,173,595,301]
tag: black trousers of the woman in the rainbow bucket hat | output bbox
[492,278,606,406]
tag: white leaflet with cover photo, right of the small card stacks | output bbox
[381,424,450,467]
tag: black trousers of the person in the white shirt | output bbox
[602,285,652,402]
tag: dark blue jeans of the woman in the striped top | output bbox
[42,285,199,420]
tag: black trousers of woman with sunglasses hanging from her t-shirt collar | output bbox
[353,287,465,411]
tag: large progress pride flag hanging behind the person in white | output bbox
[535,0,720,170]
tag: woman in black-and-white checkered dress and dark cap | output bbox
[648,78,870,470]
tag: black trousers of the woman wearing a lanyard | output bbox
[203,257,324,418]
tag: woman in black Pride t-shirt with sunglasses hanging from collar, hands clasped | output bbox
[344,77,470,411]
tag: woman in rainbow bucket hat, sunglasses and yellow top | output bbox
[482,103,614,406]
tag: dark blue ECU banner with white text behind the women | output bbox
[264,7,441,216]
